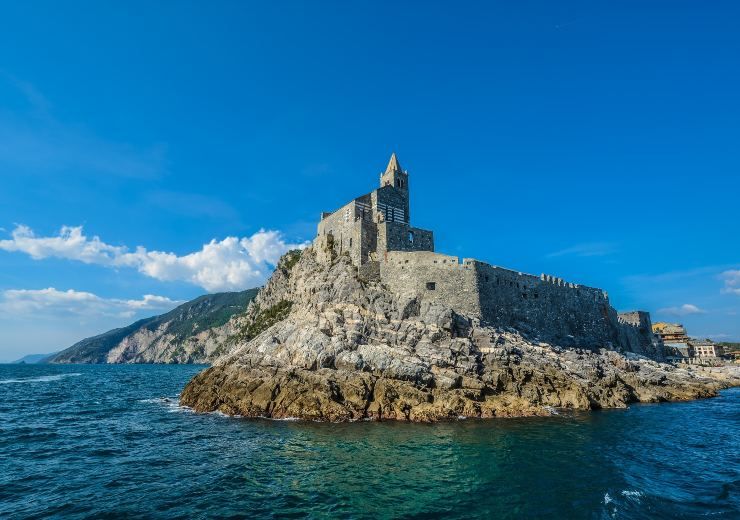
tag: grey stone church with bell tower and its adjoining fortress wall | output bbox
[317,154,652,353]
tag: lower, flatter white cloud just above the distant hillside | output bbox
[0,287,182,318]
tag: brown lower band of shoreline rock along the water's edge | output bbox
[180,353,740,422]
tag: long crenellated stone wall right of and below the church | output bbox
[380,252,632,348]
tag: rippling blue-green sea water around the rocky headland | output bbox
[0,365,740,518]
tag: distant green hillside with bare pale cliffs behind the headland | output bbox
[48,289,258,363]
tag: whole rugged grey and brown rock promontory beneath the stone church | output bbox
[181,247,740,421]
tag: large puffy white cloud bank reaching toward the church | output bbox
[0,225,306,291]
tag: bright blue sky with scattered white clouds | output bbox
[0,0,740,361]
